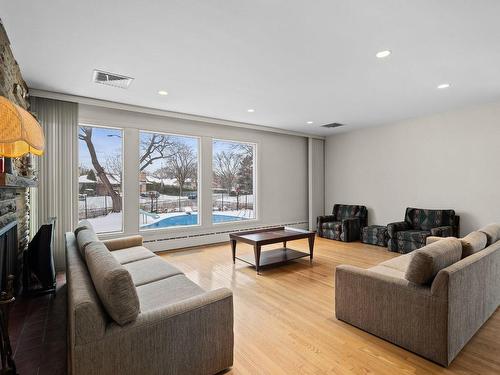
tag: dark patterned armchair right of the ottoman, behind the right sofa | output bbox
[387,207,460,254]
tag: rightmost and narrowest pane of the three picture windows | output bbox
[212,140,255,223]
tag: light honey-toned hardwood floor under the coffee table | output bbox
[162,238,500,375]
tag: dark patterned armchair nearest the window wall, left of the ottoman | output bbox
[317,204,368,242]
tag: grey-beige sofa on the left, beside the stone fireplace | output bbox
[66,222,233,375]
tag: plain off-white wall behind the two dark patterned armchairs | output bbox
[325,102,500,234]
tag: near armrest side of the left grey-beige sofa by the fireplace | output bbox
[75,288,234,375]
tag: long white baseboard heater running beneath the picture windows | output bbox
[144,221,309,251]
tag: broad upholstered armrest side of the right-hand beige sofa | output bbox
[335,265,448,364]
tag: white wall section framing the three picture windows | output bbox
[79,104,308,250]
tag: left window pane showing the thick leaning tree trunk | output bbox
[78,125,123,233]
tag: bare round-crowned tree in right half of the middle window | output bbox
[166,142,197,211]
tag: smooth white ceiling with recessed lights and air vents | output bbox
[0,0,500,135]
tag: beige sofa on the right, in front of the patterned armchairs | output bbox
[335,224,500,366]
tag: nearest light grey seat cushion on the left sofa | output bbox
[137,275,205,313]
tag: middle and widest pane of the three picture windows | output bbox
[139,132,200,230]
